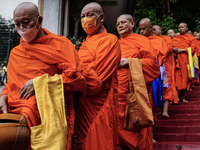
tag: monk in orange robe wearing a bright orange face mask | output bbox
[76,2,121,150]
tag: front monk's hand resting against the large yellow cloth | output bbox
[19,79,35,100]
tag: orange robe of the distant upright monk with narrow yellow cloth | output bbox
[173,34,197,90]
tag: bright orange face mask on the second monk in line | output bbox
[81,14,101,34]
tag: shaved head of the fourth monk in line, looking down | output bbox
[139,18,152,37]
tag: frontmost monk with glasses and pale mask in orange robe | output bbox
[0,2,90,149]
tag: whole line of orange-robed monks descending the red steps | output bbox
[0,2,200,150]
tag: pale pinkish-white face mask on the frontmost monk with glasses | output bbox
[17,17,40,43]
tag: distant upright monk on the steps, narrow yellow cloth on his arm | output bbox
[173,23,196,103]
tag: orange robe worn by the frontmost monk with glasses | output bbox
[1,29,86,149]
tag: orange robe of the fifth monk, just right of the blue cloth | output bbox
[160,35,178,103]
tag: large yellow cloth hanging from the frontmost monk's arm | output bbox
[31,74,68,150]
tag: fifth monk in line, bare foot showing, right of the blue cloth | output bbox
[152,25,178,117]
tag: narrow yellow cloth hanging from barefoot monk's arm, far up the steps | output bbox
[187,47,194,79]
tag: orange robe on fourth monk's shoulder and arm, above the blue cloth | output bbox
[148,34,169,66]
